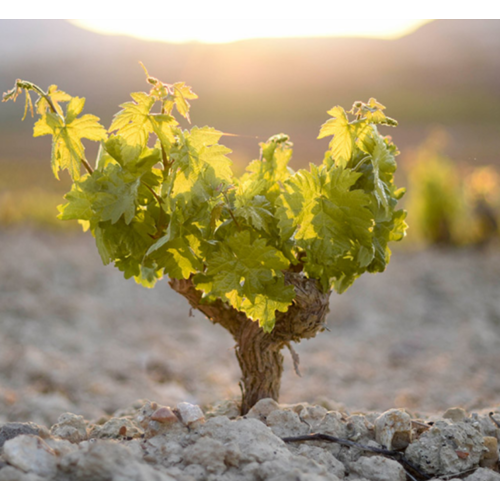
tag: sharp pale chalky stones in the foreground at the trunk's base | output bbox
[0,399,500,482]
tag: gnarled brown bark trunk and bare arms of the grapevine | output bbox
[170,272,330,415]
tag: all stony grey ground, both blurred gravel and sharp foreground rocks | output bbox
[0,230,500,481]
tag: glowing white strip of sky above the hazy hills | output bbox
[68,19,432,43]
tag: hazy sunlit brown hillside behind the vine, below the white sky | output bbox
[0,19,500,179]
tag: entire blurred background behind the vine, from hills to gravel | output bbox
[0,19,500,423]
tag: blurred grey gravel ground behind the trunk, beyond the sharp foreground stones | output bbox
[0,229,500,478]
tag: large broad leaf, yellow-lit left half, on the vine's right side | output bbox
[277,165,374,289]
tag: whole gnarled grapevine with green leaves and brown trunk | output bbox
[4,68,406,413]
